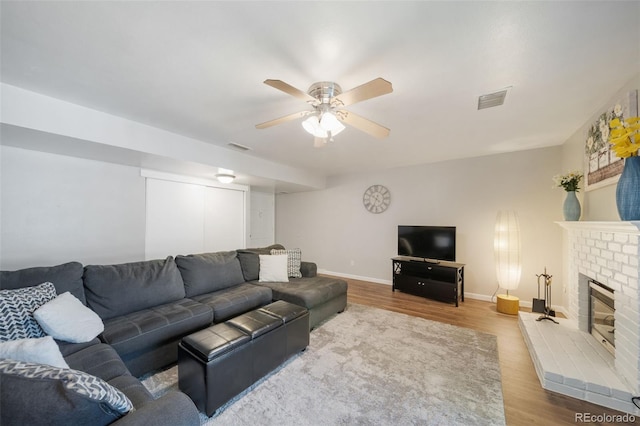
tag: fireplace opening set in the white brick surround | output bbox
[589,280,616,355]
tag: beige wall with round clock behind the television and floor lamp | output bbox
[276,147,563,303]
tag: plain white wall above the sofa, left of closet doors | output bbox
[0,146,145,270]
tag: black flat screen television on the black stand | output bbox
[398,225,456,262]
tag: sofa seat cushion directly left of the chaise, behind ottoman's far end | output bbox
[193,283,273,323]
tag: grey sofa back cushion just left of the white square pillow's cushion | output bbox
[176,251,245,297]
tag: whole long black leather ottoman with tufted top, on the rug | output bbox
[178,301,309,416]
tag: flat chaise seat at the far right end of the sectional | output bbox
[254,276,347,309]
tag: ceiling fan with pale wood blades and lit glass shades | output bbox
[256,78,393,147]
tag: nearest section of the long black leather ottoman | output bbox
[178,323,253,416]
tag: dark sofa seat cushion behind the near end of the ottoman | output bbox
[102,299,213,358]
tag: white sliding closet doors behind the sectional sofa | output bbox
[145,177,246,259]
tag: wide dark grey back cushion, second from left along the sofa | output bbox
[84,256,185,320]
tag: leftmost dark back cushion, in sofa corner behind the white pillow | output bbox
[0,262,86,303]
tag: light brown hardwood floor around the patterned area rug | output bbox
[346,279,628,426]
